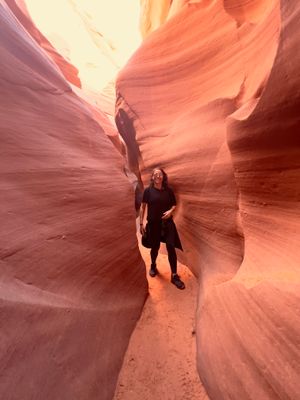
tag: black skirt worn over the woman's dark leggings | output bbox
[142,218,183,251]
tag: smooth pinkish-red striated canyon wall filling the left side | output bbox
[0,0,147,400]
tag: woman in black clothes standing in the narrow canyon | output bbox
[140,168,185,289]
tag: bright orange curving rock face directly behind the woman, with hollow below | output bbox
[116,2,279,279]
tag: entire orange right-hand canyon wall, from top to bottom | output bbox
[116,0,300,400]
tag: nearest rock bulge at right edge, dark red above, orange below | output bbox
[199,1,300,399]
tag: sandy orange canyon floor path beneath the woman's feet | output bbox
[114,247,209,400]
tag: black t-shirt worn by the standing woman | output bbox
[143,186,176,221]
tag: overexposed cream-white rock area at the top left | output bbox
[20,0,141,94]
